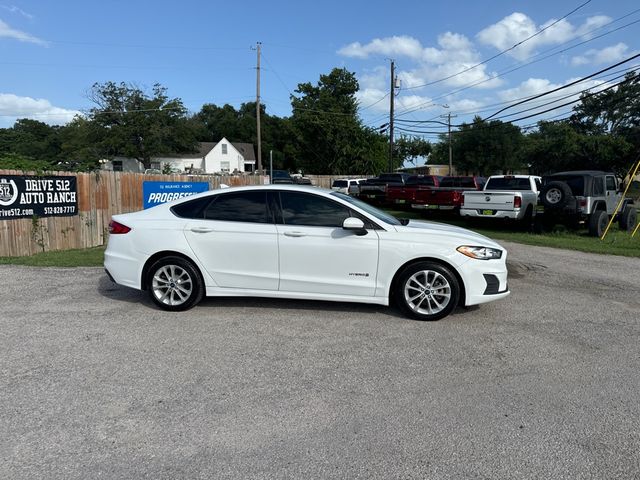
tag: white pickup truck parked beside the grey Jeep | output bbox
[460,175,542,220]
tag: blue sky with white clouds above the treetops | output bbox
[0,0,640,141]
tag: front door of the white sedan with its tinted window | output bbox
[276,191,379,296]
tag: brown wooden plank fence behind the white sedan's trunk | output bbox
[0,170,265,257]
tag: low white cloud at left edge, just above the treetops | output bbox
[0,93,81,126]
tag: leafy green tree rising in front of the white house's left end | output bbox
[89,82,196,168]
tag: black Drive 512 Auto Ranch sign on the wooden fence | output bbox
[0,175,78,220]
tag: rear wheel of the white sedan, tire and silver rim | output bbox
[147,256,204,312]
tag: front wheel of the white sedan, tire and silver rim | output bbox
[394,262,460,321]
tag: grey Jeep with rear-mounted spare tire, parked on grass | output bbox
[537,171,637,237]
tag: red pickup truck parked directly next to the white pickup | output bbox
[411,177,485,211]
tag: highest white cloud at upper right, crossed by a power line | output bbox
[476,12,611,60]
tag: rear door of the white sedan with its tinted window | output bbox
[184,190,278,290]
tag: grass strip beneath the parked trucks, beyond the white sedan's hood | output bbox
[387,210,640,257]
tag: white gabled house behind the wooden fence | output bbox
[105,138,256,174]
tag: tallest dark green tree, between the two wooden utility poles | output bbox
[291,68,387,174]
